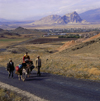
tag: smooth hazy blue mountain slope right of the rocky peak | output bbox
[79,8,100,23]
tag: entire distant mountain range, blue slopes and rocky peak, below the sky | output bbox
[0,8,100,26]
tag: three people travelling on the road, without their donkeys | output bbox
[7,52,41,78]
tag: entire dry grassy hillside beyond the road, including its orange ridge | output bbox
[0,31,100,80]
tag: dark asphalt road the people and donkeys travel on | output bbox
[0,67,100,101]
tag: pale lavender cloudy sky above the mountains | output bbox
[0,0,100,20]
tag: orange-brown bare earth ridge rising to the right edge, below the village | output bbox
[57,34,100,52]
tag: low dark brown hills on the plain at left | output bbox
[0,27,45,39]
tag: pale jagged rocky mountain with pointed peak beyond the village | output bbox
[32,12,86,25]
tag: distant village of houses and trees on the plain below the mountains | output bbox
[43,28,100,38]
